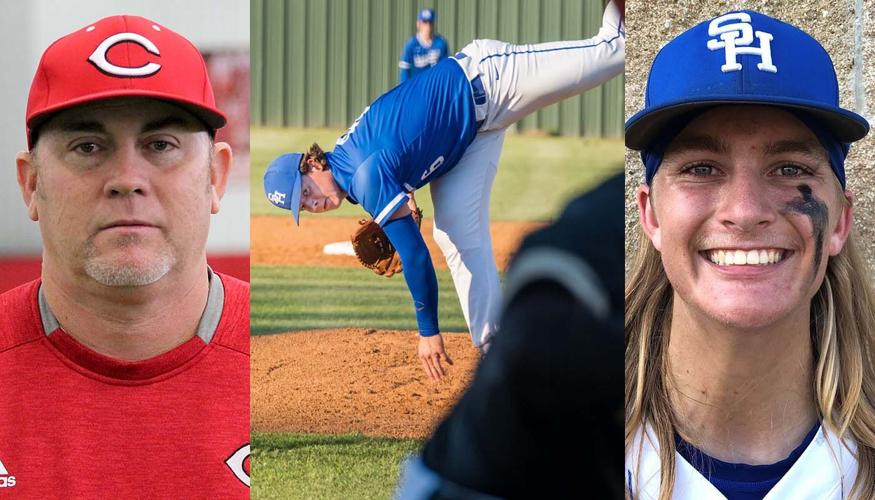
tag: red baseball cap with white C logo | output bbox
[26,16,227,148]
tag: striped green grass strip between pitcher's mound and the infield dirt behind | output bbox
[250,266,468,335]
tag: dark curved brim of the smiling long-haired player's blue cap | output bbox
[625,95,869,151]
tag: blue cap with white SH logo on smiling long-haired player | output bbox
[625,10,869,185]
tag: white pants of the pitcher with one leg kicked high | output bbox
[431,2,625,347]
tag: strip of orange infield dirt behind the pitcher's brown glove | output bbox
[250,215,544,269]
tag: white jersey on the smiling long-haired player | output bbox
[624,425,857,500]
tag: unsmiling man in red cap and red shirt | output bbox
[0,16,249,498]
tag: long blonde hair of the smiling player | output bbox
[625,205,875,500]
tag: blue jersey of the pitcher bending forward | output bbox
[326,59,477,225]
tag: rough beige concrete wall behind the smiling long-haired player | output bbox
[625,0,875,270]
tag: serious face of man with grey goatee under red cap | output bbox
[18,98,230,286]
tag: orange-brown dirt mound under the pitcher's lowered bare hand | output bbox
[251,328,480,438]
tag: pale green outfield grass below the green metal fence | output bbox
[250,127,623,221]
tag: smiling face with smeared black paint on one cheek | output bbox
[638,106,851,328]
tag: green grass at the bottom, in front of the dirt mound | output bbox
[251,432,422,500]
